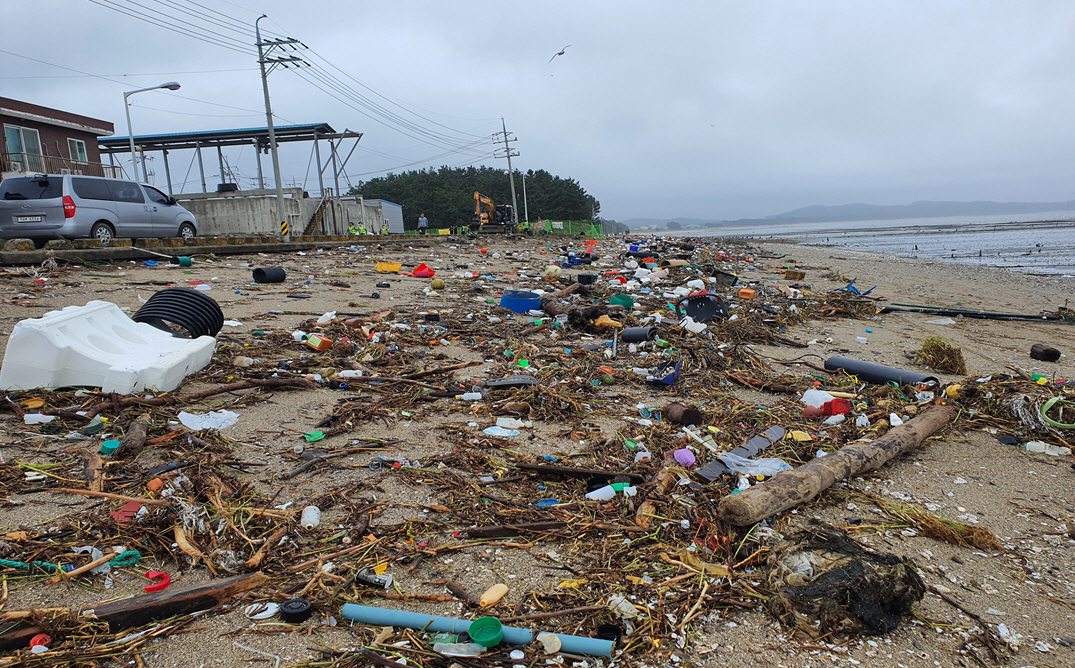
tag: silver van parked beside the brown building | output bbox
[0,174,198,244]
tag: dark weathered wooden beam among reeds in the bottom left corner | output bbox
[0,572,269,651]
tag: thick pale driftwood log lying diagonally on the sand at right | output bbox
[717,406,956,526]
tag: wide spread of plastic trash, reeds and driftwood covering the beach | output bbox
[0,232,1075,667]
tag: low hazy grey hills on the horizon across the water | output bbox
[619,200,1075,230]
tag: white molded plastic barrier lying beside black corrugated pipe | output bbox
[0,301,216,394]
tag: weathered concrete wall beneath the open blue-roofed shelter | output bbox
[169,188,309,237]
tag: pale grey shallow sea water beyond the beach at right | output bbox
[686,211,1075,278]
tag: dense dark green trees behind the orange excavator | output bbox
[347,167,601,229]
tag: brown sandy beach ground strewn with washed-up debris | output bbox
[0,237,1075,667]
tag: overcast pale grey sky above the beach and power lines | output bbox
[6,0,1075,219]
